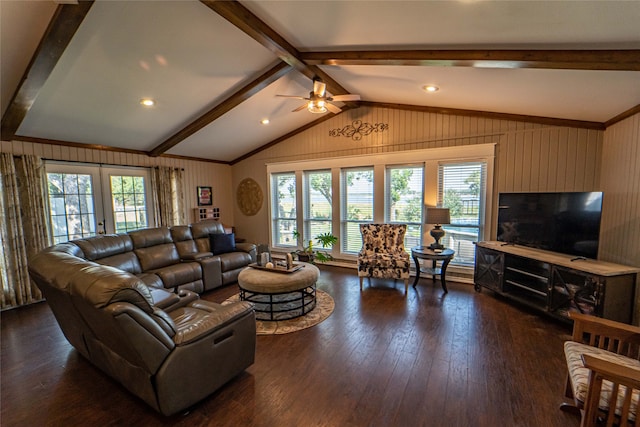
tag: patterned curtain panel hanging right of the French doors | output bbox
[151,166,185,227]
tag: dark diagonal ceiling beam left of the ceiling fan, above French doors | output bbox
[149,62,292,157]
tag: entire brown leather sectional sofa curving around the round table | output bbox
[29,221,256,415]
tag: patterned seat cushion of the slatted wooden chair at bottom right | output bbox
[564,341,640,421]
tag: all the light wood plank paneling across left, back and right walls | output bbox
[0,107,640,274]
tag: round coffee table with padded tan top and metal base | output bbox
[238,263,320,320]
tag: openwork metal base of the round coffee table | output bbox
[240,284,316,320]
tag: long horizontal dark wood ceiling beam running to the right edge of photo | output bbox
[300,50,640,71]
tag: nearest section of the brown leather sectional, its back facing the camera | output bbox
[29,243,256,415]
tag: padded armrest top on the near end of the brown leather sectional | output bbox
[174,300,254,345]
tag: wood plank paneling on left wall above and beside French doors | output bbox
[0,141,234,225]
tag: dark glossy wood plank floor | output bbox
[0,266,579,427]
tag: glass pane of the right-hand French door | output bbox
[110,175,148,233]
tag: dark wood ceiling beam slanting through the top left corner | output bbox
[1,1,93,140]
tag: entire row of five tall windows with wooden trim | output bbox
[267,143,495,270]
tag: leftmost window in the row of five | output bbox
[271,173,297,246]
